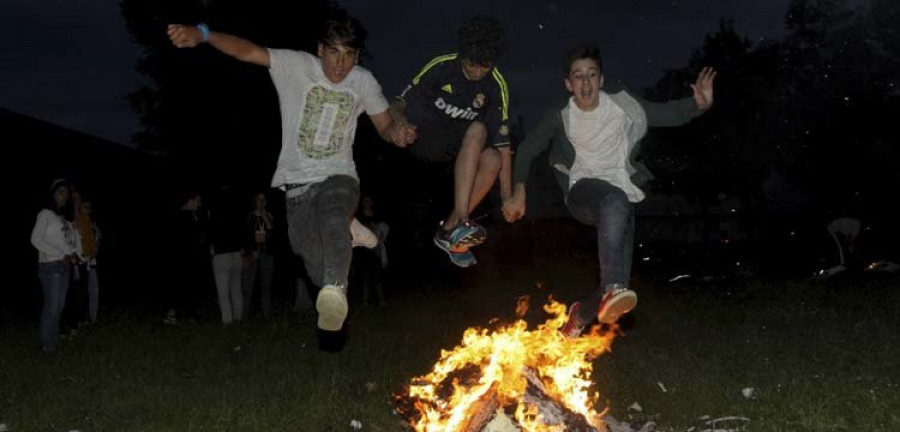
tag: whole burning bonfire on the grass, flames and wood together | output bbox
[396,300,614,432]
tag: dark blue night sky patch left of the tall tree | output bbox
[0,0,142,143]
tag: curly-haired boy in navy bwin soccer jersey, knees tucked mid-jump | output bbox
[391,18,511,267]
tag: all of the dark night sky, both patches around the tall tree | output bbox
[0,0,788,143]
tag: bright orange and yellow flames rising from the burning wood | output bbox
[401,301,614,432]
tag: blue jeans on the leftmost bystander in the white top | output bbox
[38,261,72,349]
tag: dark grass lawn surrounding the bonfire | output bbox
[0,248,900,432]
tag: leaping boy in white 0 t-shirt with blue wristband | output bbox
[168,13,413,331]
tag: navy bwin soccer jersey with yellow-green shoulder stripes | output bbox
[398,54,510,147]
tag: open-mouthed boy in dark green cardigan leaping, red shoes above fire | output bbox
[503,47,716,338]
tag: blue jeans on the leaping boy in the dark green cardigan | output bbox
[566,179,634,323]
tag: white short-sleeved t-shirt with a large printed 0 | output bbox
[269,49,388,187]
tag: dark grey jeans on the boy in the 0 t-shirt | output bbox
[287,175,359,288]
